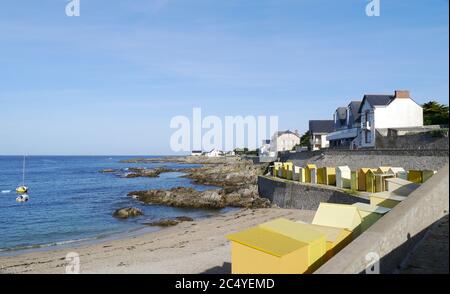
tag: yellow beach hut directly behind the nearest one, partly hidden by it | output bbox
[259,218,326,270]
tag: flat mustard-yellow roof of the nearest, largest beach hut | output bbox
[227,227,308,257]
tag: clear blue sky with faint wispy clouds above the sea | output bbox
[0,0,449,155]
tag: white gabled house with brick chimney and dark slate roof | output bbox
[355,91,423,148]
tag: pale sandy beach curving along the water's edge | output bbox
[0,208,314,274]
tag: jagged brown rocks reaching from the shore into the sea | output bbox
[114,156,271,209]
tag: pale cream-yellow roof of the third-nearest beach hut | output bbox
[312,203,362,230]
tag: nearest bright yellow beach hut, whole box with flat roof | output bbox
[227,227,309,274]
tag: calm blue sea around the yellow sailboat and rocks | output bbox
[0,156,229,252]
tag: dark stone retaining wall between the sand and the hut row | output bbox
[258,176,368,210]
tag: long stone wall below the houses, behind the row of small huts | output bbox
[279,149,448,170]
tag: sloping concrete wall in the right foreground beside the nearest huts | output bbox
[316,164,449,274]
